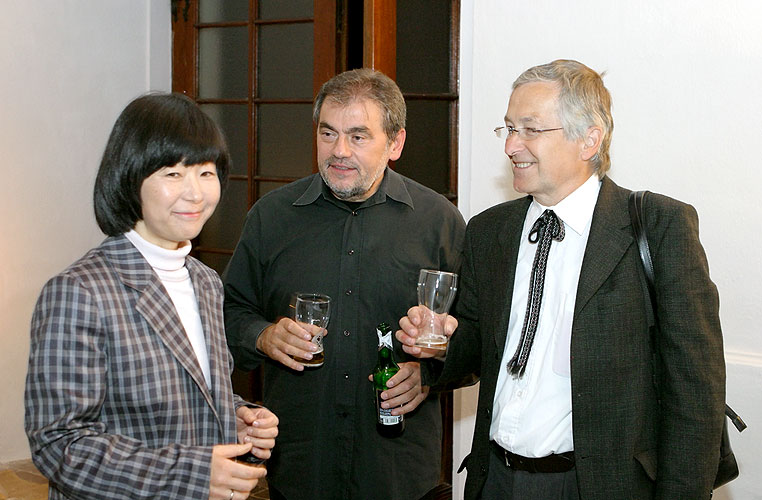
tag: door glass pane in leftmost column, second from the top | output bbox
[198,26,249,99]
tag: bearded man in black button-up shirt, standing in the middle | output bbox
[224,69,465,500]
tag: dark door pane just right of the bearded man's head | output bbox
[394,100,450,193]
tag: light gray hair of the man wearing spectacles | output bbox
[513,59,614,178]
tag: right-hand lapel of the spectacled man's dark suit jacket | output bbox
[574,177,634,319]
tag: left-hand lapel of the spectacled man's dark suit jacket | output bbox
[487,196,532,354]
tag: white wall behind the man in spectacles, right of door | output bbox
[454,0,762,500]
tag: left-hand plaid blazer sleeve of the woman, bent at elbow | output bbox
[25,275,212,500]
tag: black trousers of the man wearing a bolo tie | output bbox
[481,453,580,500]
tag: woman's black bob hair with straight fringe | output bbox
[93,93,230,236]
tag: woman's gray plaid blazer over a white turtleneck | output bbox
[25,235,243,499]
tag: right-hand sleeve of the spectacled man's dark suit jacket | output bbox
[647,195,725,500]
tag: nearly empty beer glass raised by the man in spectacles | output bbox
[415,269,458,349]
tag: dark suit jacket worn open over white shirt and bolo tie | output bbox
[426,178,725,500]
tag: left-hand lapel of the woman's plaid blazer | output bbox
[104,236,219,420]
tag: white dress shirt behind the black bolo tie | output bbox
[490,174,600,457]
